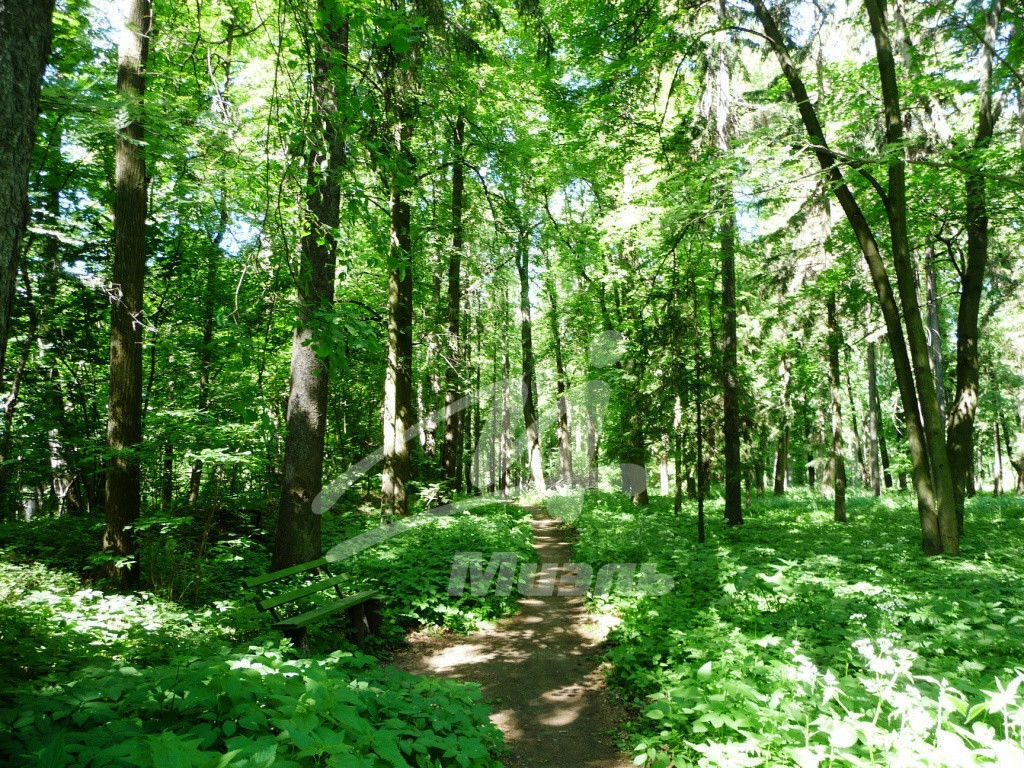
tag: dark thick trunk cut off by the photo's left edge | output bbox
[0,0,53,381]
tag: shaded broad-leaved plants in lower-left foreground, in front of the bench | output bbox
[0,645,501,768]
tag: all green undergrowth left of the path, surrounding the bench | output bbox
[0,504,532,768]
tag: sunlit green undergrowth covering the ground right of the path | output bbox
[557,494,1024,768]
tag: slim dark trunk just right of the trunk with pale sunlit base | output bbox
[441,114,467,490]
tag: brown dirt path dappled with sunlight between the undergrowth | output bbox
[394,508,632,768]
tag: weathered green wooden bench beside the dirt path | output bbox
[243,557,384,651]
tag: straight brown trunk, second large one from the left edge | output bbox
[103,0,153,587]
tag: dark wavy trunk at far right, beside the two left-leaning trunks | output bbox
[947,0,1002,534]
